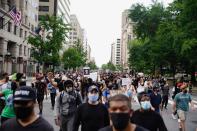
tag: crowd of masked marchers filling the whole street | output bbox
[0,72,194,131]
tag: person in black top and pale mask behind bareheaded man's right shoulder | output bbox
[131,92,167,131]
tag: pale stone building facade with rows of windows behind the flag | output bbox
[0,0,39,75]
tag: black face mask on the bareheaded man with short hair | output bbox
[110,113,130,130]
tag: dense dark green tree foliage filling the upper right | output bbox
[129,0,197,80]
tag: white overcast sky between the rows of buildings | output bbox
[70,0,173,67]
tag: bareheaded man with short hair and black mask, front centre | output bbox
[99,94,149,131]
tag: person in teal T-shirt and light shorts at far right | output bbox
[173,83,195,131]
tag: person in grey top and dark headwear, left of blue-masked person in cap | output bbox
[55,79,82,131]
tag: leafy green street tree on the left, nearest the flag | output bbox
[27,15,70,72]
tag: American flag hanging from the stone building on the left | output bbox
[9,7,22,26]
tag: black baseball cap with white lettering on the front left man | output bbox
[14,86,36,101]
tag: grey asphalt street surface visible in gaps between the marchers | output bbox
[35,93,197,131]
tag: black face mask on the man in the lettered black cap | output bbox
[14,106,34,119]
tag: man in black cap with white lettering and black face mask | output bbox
[0,86,54,131]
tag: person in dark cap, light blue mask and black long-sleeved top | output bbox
[73,85,110,131]
